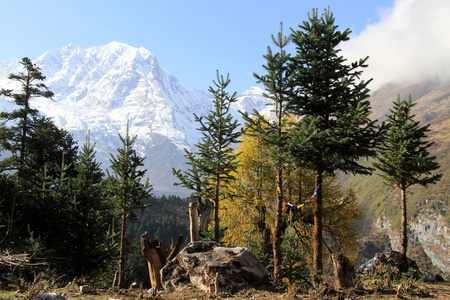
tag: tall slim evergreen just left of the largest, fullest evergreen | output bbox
[243,25,292,282]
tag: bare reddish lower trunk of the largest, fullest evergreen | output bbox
[313,171,323,283]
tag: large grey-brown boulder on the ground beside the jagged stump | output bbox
[161,242,269,293]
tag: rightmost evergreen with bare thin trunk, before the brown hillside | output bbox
[374,95,442,257]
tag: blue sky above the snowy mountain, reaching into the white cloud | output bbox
[0,0,450,93]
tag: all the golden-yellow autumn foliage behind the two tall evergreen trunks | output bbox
[220,123,362,278]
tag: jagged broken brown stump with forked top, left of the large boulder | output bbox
[141,232,184,290]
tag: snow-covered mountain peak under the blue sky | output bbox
[0,42,268,193]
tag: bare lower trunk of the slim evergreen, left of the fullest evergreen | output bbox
[273,169,283,283]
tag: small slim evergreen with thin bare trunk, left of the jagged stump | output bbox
[110,123,152,288]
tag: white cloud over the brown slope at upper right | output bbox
[342,0,450,90]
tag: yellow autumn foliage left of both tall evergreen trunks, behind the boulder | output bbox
[221,127,276,262]
